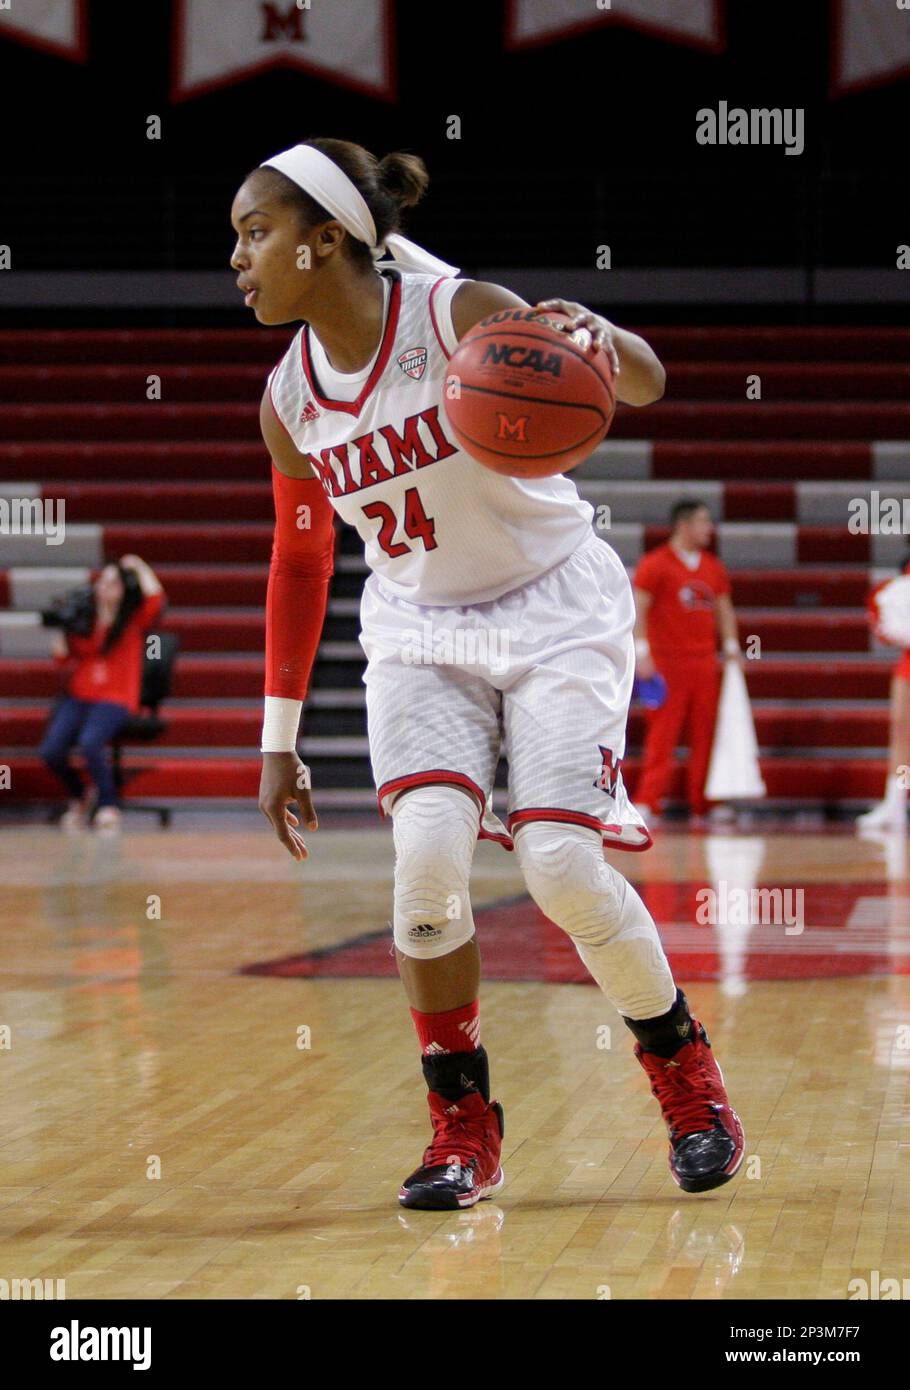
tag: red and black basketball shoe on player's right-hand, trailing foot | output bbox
[635,1019,746,1193]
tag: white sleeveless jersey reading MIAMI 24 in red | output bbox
[268,267,593,605]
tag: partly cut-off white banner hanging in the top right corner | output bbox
[831,0,910,96]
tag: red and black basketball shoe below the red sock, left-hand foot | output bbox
[399,1091,506,1211]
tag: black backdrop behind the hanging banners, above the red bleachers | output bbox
[0,0,910,290]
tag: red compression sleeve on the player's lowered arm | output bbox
[265,463,335,699]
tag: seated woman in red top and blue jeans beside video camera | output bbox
[40,555,164,830]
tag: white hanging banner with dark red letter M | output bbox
[172,0,395,101]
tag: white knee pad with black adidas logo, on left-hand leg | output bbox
[392,784,479,960]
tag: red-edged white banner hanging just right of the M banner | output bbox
[506,0,724,53]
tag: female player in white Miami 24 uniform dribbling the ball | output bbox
[231,139,743,1208]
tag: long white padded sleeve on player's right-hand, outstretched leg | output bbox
[514,820,675,1019]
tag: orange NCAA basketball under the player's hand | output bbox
[443,309,615,478]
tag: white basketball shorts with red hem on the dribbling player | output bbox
[360,531,652,849]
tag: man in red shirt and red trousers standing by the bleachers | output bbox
[634,500,739,823]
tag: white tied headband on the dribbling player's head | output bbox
[260,145,458,275]
